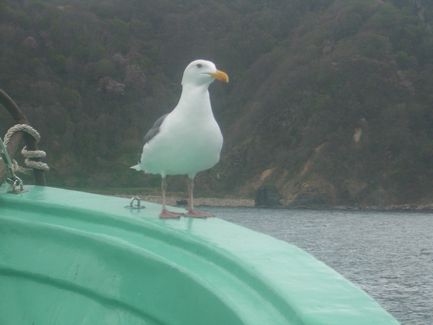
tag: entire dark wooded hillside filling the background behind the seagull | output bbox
[0,0,433,207]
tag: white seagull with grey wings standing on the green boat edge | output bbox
[131,60,229,219]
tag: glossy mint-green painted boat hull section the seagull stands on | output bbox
[0,187,398,325]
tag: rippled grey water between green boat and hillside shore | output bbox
[209,208,433,325]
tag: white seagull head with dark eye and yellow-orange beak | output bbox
[182,60,229,87]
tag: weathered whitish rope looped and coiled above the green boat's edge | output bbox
[4,124,50,173]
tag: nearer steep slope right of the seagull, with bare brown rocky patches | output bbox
[204,2,433,207]
